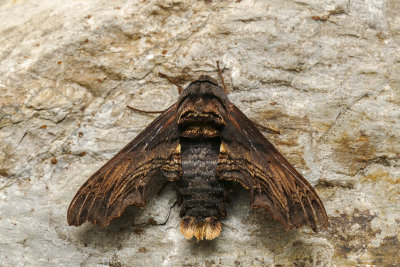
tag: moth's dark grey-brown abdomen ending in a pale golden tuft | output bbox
[178,137,226,239]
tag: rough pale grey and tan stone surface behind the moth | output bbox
[0,0,400,266]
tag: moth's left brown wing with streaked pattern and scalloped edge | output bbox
[67,104,179,226]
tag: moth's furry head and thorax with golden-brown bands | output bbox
[178,75,229,132]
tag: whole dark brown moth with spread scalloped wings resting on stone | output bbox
[68,76,328,240]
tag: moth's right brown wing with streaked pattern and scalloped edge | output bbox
[217,104,328,231]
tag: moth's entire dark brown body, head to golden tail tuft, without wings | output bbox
[173,77,233,240]
